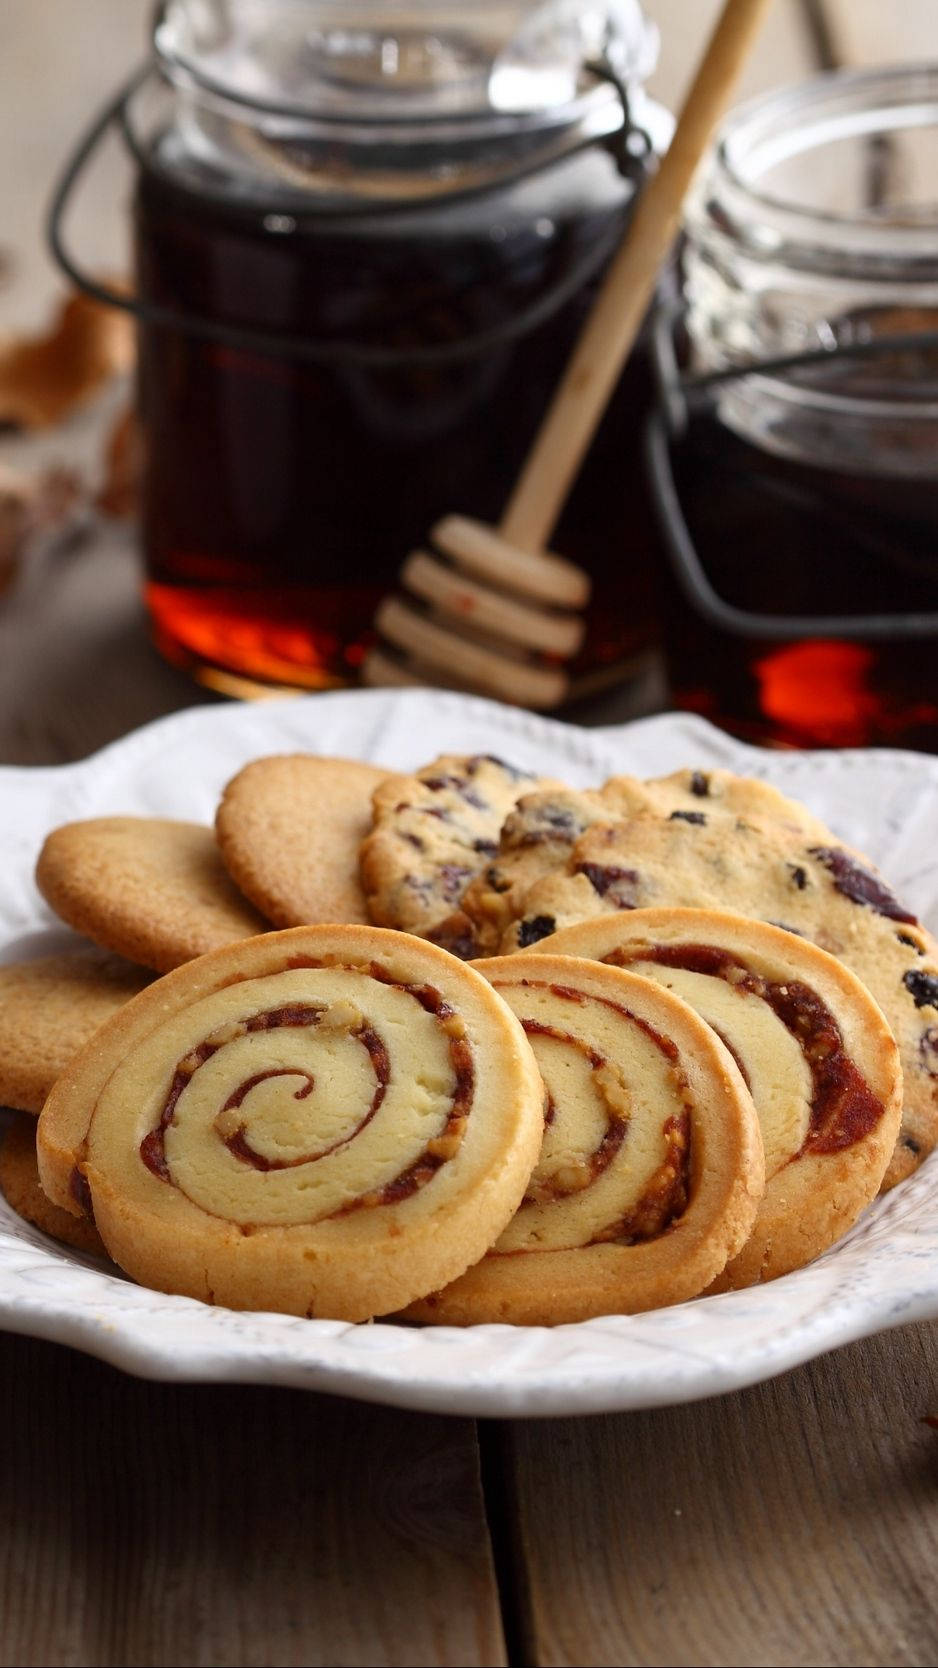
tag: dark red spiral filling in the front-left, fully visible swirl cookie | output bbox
[134,957,476,1216]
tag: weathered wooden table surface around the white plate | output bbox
[0,529,938,1665]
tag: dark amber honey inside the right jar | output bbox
[650,417,938,751]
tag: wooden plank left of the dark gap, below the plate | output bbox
[0,1338,506,1668]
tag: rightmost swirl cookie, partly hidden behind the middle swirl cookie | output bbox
[524,909,901,1289]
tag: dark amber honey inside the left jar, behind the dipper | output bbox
[135,140,654,689]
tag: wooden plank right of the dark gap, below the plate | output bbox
[501,1326,938,1668]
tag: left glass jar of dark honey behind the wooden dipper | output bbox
[51,0,669,691]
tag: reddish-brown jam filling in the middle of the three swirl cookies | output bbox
[484,979,691,1254]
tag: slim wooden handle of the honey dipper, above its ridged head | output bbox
[501,0,769,550]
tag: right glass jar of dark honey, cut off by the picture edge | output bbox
[649,65,938,751]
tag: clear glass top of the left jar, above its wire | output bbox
[154,0,658,123]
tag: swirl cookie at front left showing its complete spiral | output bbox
[38,926,544,1321]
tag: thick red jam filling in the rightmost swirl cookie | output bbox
[603,944,883,1158]
